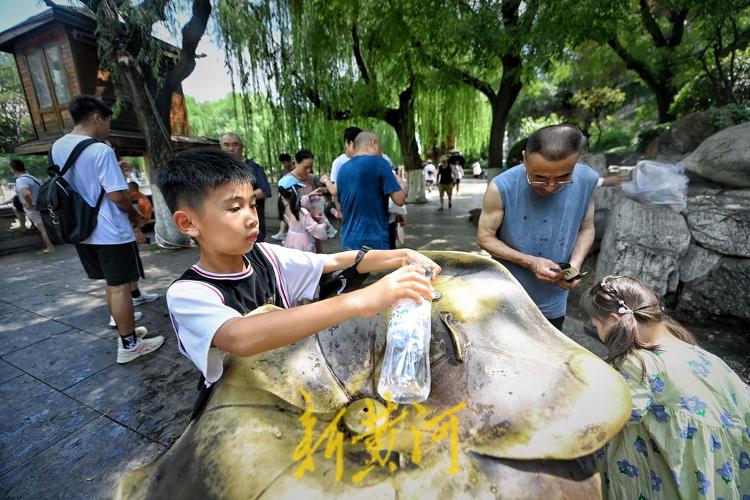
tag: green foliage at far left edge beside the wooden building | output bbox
[0,53,34,153]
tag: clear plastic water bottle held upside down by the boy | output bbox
[378,272,432,403]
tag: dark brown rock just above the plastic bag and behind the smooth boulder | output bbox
[646,111,732,160]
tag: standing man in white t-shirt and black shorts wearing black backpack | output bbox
[48,95,164,363]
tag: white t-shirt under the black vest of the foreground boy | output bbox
[167,243,326,385]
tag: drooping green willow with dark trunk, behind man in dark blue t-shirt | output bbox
[217,0,434,202]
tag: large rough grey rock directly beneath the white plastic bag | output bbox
[596,197,690,295]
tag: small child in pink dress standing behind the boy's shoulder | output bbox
[279,187,328,253]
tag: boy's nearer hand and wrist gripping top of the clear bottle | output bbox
[352,266,432,318]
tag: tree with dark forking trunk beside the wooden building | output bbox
[71,0,211,247]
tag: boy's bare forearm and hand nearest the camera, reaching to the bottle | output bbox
[213,264,430,356]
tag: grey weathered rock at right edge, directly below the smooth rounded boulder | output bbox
[687,192,750,257]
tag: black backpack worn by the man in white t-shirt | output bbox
[36,139,104,243]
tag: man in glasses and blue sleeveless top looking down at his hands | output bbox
[477,125,599,330]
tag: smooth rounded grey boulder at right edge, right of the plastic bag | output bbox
[683,122,750,187]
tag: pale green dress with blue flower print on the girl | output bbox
[594,340,750,500]
